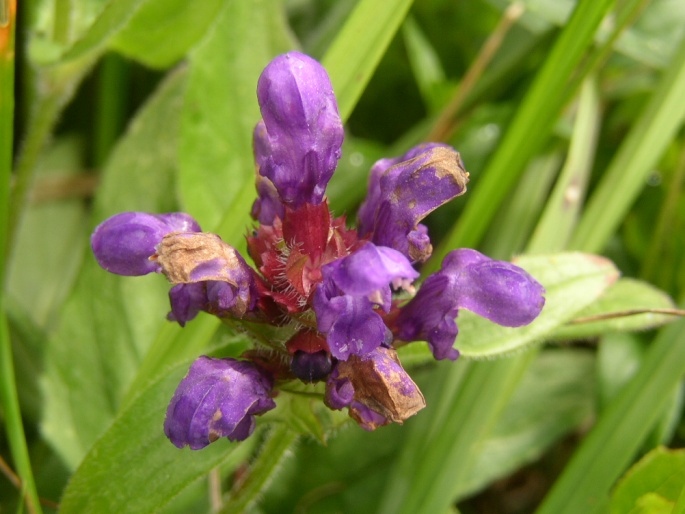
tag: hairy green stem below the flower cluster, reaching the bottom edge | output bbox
[219,424,297,514]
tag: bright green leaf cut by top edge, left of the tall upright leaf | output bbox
[110,0,222,68]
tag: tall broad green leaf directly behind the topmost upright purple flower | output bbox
[178,0,294,229]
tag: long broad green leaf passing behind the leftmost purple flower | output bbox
[41,68,184,468]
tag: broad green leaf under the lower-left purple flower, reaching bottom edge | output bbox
[60,356,251,514]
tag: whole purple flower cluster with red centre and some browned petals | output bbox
[92,52,544,449]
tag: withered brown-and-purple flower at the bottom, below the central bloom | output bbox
[326,346,426,430]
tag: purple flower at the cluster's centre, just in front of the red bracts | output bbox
[313,243,418,360]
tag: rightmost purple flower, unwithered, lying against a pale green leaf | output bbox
[397,248,545,360]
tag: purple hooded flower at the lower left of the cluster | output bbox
[164,356,276,450]
